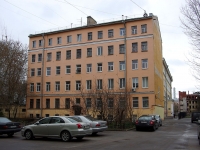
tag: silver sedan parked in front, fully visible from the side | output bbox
[21,116,92,141]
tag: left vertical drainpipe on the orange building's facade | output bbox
[40,33,45,117]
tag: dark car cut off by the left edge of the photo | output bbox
[0,117,21,137]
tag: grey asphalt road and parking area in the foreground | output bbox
[0,118,200,150]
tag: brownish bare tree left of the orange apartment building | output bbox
[0,38,28,118]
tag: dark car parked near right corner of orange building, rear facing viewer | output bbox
[135,115,159,131]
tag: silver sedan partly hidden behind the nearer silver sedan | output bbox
[70,116,108,135]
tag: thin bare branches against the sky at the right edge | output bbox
[181,0,200,80]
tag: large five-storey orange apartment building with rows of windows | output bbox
[26,14,164,118]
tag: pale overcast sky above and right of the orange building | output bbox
[0,0,199,98]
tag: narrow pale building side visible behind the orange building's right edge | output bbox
[163,58,174,117]
